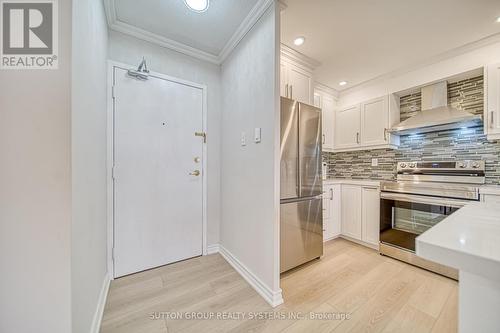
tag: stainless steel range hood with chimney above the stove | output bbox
[389,81,482,135]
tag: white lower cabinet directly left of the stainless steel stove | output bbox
[328,184,380,247]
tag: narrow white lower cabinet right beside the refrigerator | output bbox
[323,185,341,241]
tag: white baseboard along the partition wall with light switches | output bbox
[219,245,283,307]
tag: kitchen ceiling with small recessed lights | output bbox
[281,0,500,90]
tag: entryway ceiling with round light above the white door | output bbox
[111,0,259,57]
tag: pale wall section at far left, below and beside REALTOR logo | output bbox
[0,1,71,333]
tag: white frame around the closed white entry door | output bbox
[106,60,208,280]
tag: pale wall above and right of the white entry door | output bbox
[109,31,221,245]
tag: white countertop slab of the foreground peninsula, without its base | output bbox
[416,202,500,281]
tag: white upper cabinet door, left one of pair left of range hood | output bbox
[334,105,361,150]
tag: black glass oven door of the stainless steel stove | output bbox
[380,192,470,252]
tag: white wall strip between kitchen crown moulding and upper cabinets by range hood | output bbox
[339,42,500,106]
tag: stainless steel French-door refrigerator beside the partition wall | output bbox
[280,97,323,272]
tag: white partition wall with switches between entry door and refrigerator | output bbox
[221,5,281,304]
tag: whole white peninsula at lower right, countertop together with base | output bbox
[416,202,500,333]
